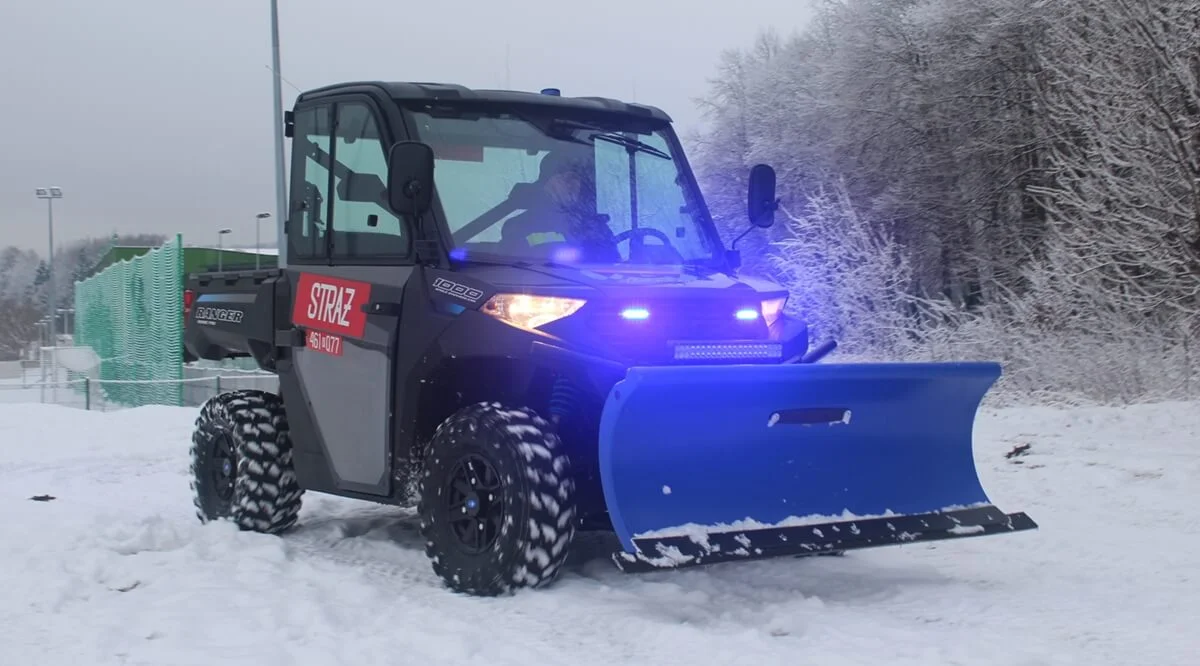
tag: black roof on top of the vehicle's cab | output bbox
[298,80,671,122]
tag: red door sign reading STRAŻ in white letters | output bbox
[292,272,371,337]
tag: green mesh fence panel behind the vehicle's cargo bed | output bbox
[74,235,184,407]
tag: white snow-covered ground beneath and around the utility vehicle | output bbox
[0,403,1200,666]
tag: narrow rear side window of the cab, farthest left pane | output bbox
[288,107,331,260]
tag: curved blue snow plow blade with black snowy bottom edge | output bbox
[599,362,1037,571]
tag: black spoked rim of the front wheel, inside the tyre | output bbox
[445,454,504,554]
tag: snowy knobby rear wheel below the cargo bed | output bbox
[191,390,304,534]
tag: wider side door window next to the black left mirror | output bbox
[332,102,409,259]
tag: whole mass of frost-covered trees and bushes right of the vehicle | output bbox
[697,0,1200,400]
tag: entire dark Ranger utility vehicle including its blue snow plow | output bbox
[185,82,1036,595]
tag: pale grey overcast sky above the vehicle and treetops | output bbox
[0,0,809,253]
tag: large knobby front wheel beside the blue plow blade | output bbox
[418,403,575,596]
